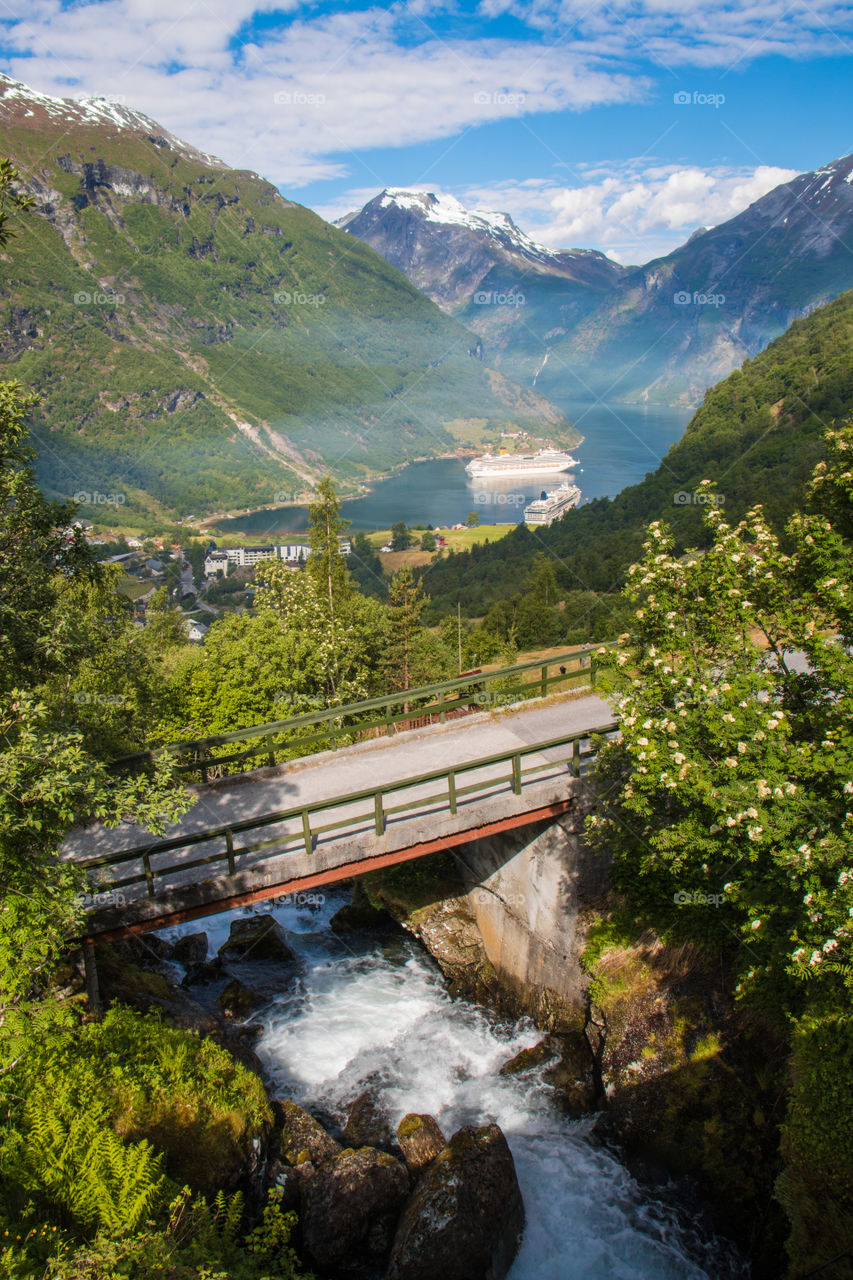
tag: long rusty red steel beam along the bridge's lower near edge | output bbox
[85,796,575,945]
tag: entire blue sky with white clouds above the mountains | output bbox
[0,0,853,262]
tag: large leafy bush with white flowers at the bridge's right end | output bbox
[588,429,853,1007]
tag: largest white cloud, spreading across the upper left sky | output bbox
[0,0,648,187]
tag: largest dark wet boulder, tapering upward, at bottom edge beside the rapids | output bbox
[388,1124,524,1280]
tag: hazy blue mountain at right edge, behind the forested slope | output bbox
[537,155,853,402]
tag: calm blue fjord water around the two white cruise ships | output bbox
[213,401,693,538]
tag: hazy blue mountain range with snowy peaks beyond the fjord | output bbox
[341,156,853,406]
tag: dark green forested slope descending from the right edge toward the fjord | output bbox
[428,292,853,617]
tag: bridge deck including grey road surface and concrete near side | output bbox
[65,695,611,934]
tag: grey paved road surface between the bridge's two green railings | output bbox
[65,694,612,859]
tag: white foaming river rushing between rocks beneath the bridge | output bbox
[161,892,748,1280]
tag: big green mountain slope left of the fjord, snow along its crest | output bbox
[0,77,578,517]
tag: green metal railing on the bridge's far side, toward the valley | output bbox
[113,646,594,782]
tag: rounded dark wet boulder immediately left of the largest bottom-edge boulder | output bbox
[300,1147,409,1276]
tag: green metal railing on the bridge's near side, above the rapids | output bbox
[87,723,617,899]
